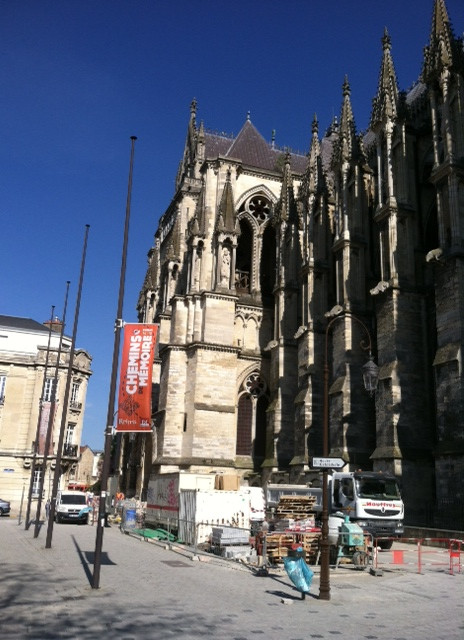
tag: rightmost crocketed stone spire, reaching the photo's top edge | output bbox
[422,0,464,82]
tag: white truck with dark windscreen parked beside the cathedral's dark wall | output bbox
[266,471,404,549]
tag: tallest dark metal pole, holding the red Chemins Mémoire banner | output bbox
[92,136,137,589]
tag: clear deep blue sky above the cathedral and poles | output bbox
[0,0,464,449]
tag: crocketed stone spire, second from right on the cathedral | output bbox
[371,27,399,127]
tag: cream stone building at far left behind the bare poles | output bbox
[0,316,92,514]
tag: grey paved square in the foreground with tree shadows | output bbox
[0,517,464,640]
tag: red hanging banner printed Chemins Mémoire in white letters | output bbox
[116,324,158,432]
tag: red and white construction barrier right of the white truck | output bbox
[373,537,464,575]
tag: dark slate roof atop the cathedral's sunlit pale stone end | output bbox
[205,120,308,174]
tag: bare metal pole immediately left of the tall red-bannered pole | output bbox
[45,224,90,549]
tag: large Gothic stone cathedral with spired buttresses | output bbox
[127,0,464,525]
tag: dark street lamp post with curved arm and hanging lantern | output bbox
[319,307,378,600]
